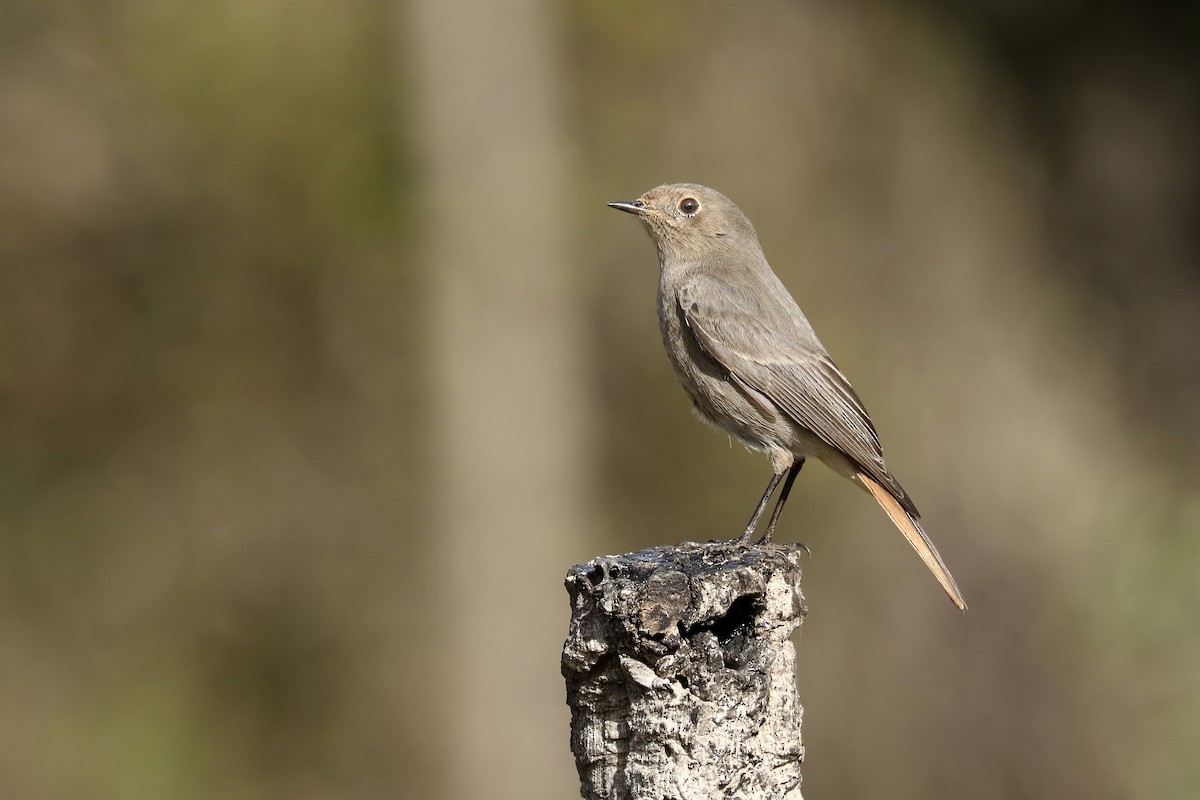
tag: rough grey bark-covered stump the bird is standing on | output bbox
[563,542,805,800]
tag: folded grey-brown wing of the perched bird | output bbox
[676,276,917,515]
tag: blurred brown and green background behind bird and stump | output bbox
[0,0,1200,800]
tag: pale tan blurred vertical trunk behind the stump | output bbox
[402,0,588,800]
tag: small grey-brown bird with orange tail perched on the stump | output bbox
[608,184,967,612]
